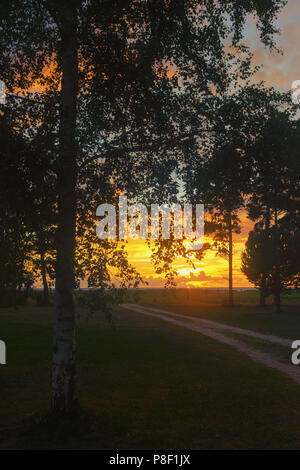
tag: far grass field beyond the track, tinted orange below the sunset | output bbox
[128,289,300,339]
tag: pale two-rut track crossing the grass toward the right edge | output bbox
[121,304,300,384]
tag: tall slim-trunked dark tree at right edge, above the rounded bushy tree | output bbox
[247,110,300,311]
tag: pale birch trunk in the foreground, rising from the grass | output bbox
[51,2,78,413]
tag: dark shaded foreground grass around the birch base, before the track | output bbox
[0,298,300,449]
